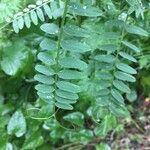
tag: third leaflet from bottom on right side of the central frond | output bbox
[56,89,79,100]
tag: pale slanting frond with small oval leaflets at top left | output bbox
[12,0,63,33]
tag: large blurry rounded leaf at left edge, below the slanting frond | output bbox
[0,40,31,76]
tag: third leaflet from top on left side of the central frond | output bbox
[38,52,55,65]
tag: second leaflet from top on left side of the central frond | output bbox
[40,38,57,51]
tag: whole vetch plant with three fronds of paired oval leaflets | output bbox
[12,0,148,117]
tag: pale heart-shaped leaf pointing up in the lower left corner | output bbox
[7,110,26,137]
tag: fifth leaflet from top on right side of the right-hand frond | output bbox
[115,71,136,82]
